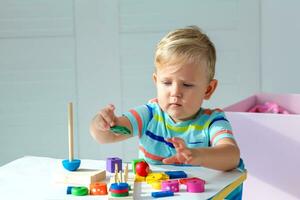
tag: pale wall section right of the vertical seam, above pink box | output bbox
[261,0,300,93]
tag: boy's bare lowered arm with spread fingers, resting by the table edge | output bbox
[163,138,240,171]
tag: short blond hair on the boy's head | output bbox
[154,26,216,81]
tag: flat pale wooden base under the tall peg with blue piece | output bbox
[56,169,106,185]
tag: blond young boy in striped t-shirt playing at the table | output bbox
[90,26,240,171]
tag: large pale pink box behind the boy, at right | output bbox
[224,93,300,199]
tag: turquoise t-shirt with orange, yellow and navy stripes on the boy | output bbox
[124,101,234,164]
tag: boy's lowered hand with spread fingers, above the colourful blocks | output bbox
[162,137,194,164]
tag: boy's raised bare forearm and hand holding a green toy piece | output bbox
[90,105,133,144]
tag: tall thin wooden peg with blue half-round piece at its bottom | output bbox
[62,103,80,171]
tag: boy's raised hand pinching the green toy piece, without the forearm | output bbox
[95,104,117,131]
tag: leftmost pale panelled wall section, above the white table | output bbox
[0,0,76,164]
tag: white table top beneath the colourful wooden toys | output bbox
[0,156,244,199]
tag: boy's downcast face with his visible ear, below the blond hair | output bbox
[153,61,217,122]
